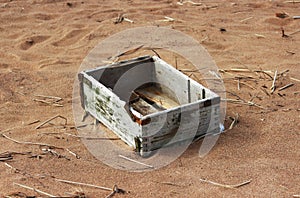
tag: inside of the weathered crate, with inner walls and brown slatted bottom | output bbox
[87,56,213,119]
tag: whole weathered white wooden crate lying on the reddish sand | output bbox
[79,56,220,155]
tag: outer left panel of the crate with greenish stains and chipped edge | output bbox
[82,74,141,147]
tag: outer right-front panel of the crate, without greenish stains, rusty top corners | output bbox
[142,98,220,152]
